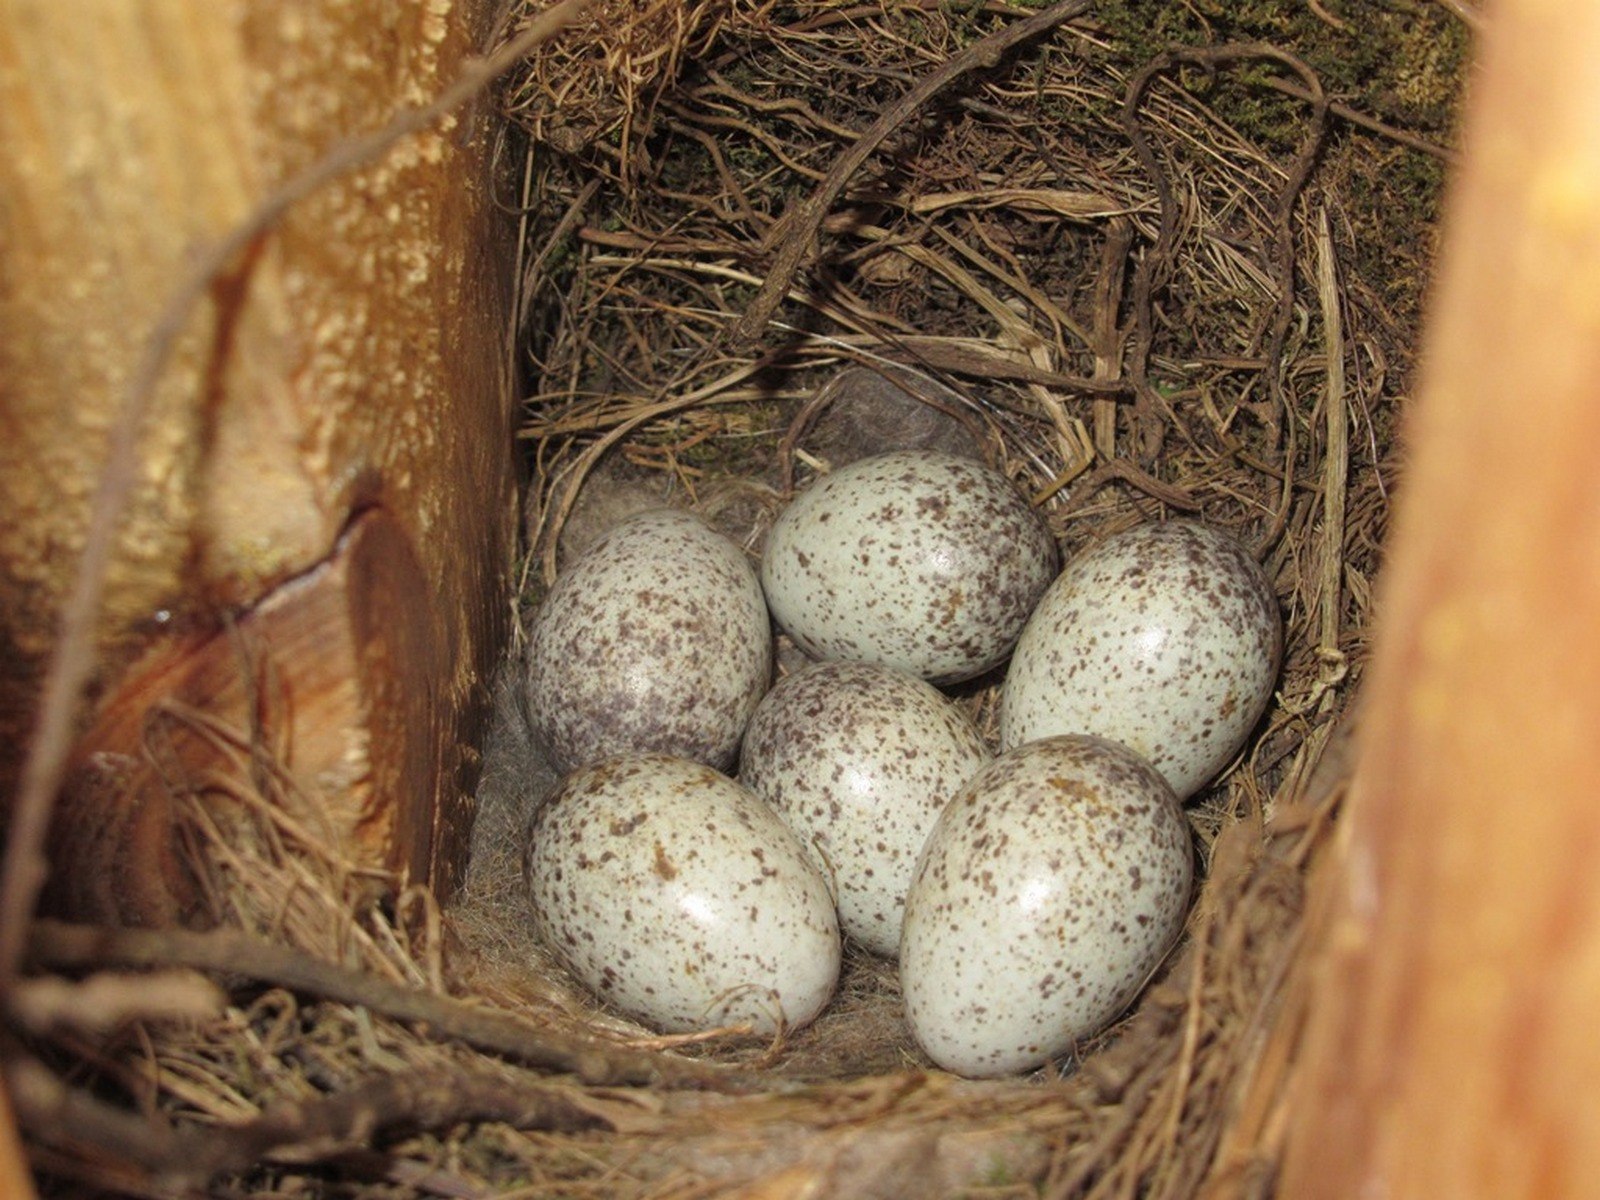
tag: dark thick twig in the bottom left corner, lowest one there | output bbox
[6,1058,610,1184]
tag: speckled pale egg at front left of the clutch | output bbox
[523,755,840,1034]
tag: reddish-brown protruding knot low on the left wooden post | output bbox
[46,509,453,925]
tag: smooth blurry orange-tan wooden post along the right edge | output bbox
[1278,0,1600,1200]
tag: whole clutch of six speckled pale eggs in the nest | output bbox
[525,464,1282,1075]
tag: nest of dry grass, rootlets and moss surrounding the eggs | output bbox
[9,2,1466,1197]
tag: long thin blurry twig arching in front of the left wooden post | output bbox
[0,0,589,1003]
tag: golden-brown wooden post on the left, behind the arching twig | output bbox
[0,0,515,918]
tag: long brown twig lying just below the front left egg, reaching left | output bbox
[29,920,747,1091]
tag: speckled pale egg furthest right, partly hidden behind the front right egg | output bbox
[1000,522,1283,798]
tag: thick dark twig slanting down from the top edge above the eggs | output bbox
[733,0,1091,347]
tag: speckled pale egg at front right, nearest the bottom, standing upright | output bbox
[899,736,1192,1078]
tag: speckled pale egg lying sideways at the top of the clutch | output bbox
[762,450,1056,683]
